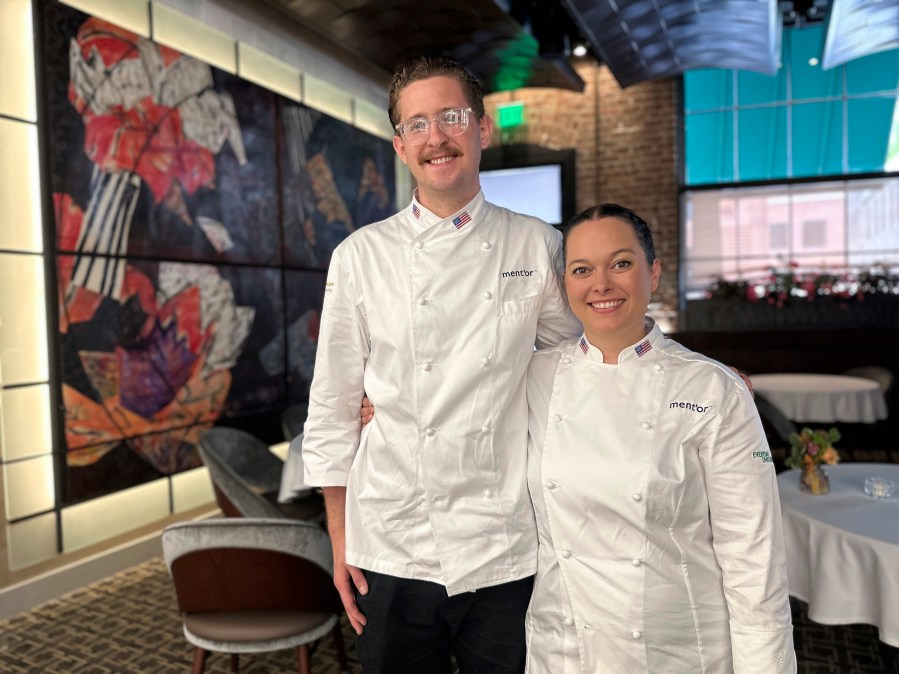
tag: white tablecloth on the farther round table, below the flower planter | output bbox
[752,374,887,424]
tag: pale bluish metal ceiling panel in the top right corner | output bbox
[821,0,899,70]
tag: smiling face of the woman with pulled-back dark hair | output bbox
[565,217,662,363]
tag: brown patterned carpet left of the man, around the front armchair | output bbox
[0,558,362,674]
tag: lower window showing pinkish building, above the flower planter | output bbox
[682,178,899,299]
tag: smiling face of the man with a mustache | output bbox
[393,76,493,217]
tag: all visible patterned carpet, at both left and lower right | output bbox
[0,559,899,674]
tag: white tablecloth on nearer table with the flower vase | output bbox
[777,463,899,647]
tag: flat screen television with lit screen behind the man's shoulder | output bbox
[481,145,575,228]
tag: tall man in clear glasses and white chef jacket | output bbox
[303,58,580,674]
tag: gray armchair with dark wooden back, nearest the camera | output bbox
[162,518,348,674]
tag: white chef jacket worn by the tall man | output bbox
[303,192,580,595]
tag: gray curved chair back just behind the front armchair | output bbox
[199,427,284,518]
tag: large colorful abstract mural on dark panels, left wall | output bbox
[42,0,395,503]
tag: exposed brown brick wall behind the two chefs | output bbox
[486,63,679,316]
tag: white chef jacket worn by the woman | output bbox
[527,320,796,674]
